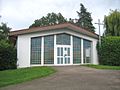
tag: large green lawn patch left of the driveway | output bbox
[0,67,55,87]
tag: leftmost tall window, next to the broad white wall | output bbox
[30,37,41,64]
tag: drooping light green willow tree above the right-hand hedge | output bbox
[104,9,120,36]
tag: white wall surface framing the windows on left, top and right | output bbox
[17,29,98,68]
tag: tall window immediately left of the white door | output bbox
[44,35,54,64]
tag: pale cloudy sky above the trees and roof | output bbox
[0,0,120,34]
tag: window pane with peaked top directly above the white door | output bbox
[56,33,70,45]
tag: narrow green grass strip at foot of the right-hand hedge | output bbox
[83,64,120,70]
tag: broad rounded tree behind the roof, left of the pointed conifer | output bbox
[30,12,67,27]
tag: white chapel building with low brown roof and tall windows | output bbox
[10,23,98,68]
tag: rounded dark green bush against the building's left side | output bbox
[0,40,17,70]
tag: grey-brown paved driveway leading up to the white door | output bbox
[2,66,120,90]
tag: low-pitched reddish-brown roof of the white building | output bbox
[9,23,98,38]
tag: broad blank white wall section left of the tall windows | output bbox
[17,35,30,67]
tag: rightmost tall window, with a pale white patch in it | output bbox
[83,40,91,63]
